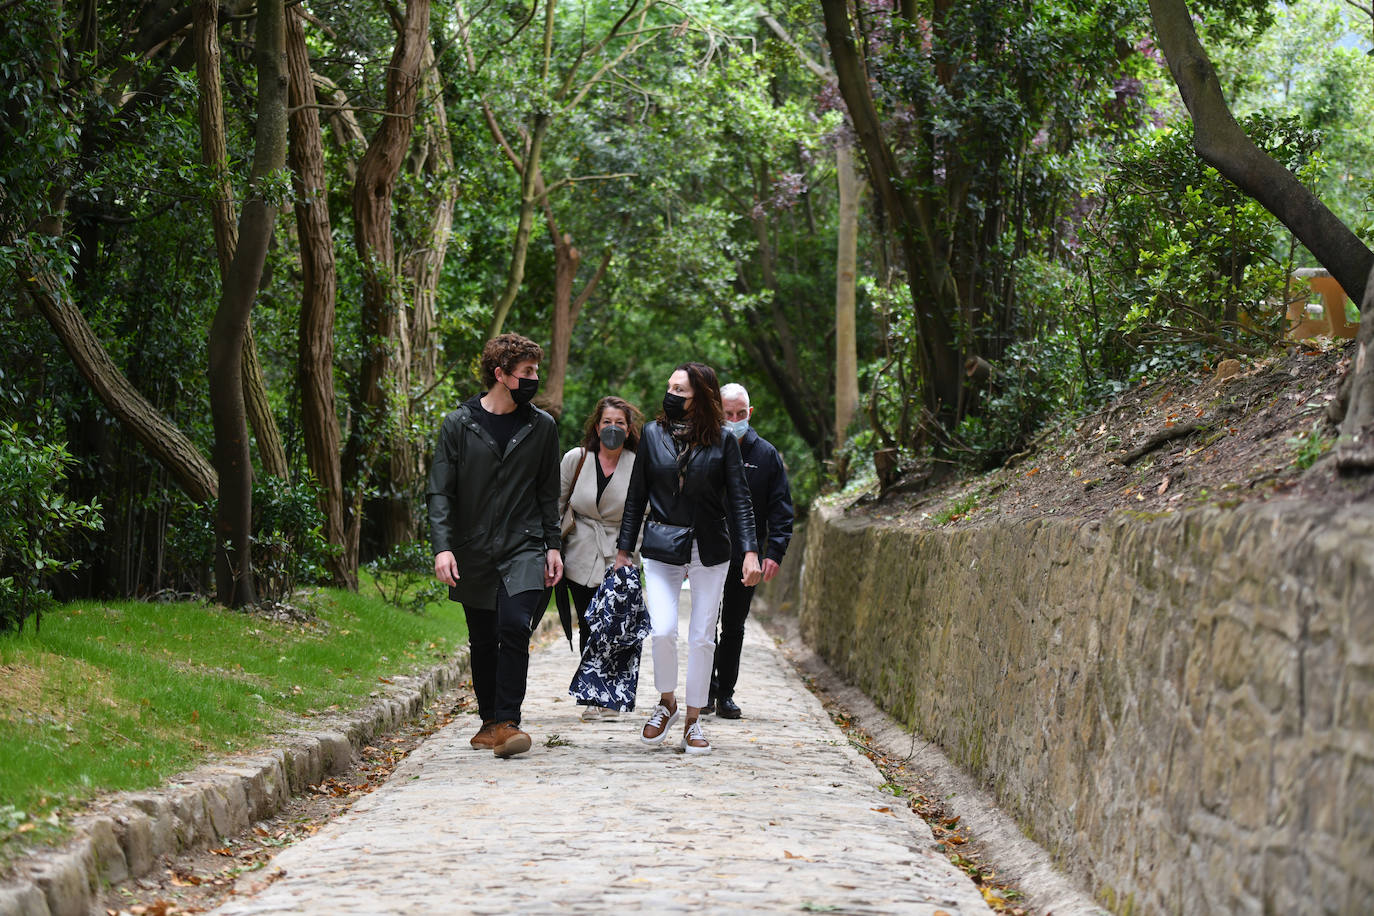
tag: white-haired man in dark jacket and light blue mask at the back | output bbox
[702,383,791,718]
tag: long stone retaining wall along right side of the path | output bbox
[801,503,1374,915]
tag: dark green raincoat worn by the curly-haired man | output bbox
[429,398,563,608]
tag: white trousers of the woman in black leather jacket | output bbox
[644,542,730,706]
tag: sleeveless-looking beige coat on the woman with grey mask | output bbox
[558,445,638,588]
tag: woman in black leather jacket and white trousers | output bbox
[616,363,760,754]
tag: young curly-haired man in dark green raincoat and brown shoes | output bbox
[429,334,563,757]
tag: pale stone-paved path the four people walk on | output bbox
[208,587,991,916]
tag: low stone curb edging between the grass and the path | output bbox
[0,645,469,916]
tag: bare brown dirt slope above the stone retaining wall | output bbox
[851,342,1374,527]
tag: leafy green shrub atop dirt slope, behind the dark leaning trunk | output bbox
[1080,114,1322,362]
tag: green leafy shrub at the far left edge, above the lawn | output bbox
[0,420,104,630]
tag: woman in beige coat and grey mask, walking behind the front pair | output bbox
[558,397,640,720]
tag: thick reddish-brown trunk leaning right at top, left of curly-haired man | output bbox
[344,0,430,560]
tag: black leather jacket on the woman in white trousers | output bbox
[616,423,758,566]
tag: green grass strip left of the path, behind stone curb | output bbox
[0,581,467,861]
